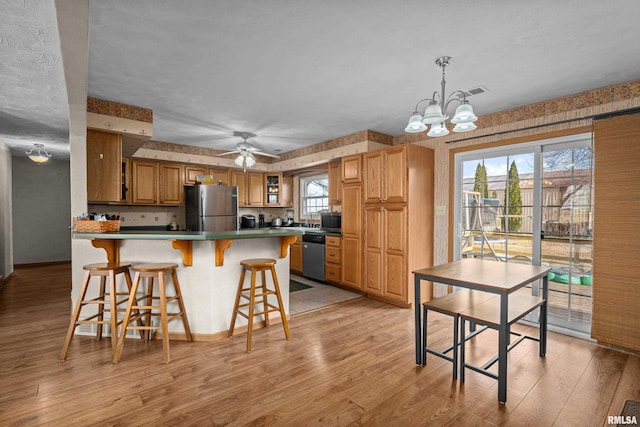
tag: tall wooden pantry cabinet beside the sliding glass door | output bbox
[362,144,434,307]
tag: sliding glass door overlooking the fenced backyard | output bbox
[454,134,593,333]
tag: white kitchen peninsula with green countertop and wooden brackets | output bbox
[72,228,304,340]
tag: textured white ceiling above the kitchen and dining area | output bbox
[0,0,640,160]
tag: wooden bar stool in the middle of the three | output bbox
[113,263,192,363]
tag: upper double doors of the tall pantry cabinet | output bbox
[363,146,408,203]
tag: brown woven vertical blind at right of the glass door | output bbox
[591,114,640,352]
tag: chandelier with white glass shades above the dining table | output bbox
[405,56,478,137]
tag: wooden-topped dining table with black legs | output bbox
[413,258,551,404]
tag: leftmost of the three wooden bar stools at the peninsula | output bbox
[60,262,142,360]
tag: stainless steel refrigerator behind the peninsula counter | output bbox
[184,184,238,231]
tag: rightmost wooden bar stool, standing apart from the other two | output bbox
[229,258,291,352]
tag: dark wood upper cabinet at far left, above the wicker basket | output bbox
[87,130,122,202]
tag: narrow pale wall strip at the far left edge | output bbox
[0,142,13,277]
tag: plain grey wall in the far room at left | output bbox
[12,156,71,264]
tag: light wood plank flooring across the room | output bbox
[0,265,640,426]
